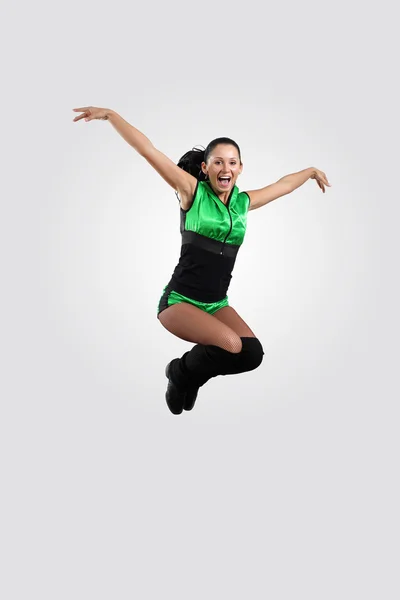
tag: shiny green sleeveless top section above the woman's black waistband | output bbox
[184,181,250,245]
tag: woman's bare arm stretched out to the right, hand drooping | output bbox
[247,167,331,210]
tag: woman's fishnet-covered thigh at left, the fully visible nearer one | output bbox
[158,302,242,353]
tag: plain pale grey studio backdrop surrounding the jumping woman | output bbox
[0,1,400,600]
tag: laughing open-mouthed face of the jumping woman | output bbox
[201,144,243,193]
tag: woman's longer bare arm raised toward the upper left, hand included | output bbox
[73,106,197,198]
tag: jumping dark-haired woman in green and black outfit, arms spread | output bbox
[73,106,330,415]
